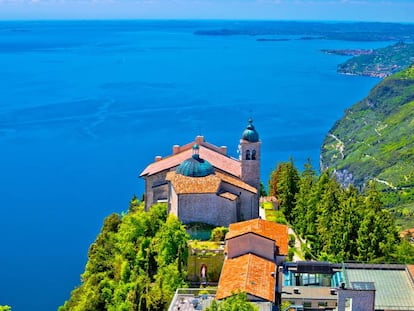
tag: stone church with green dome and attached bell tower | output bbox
[140,119,261,226]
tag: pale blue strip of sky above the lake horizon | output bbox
[0,0,414,23]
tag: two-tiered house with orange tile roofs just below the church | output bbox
[216,218,288,304]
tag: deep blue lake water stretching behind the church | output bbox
[0,21,386,311]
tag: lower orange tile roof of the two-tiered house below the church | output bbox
[216,254,276,302]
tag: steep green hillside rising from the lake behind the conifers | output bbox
[321,66,414,227]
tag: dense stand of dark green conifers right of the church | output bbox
[269,160,412,263]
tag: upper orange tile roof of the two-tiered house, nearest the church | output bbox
[226,218,289,255]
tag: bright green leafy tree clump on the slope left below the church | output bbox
[59,198,188,311]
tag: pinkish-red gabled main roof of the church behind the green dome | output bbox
[140,141,241,177]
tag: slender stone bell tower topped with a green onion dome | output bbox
[239,118,261,194]
